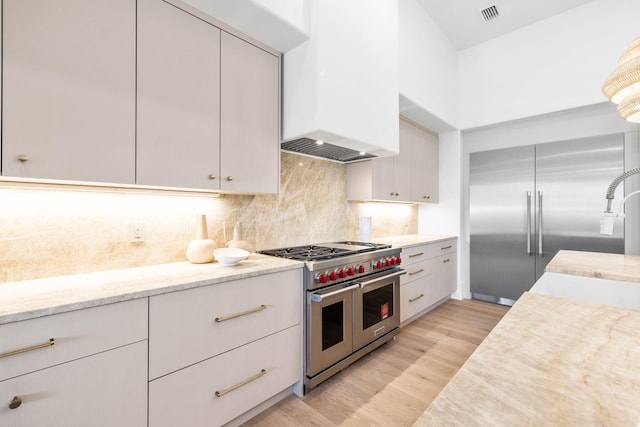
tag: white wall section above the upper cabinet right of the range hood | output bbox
[398,0,458,132]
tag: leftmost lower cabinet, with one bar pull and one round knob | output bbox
[0,298,148,427]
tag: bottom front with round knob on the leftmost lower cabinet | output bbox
[0,341,148,427]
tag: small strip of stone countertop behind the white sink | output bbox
[545,251,640,283]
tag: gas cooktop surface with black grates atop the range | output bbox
[258,241,391,261]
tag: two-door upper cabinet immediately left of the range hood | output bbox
[137,0,280,193]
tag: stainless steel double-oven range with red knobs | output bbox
[260,241,405,392]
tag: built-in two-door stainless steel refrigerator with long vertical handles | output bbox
[469,135,624,305]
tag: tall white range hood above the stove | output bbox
[282,0,399,161]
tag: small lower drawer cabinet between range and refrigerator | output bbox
[400,239,457,323]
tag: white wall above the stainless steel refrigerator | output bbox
[459,0,640,129]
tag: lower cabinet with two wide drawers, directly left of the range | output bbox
[149,268,302,427]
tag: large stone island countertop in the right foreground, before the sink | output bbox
[415,292,640,427]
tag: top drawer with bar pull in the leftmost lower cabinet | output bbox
[0,298,148,380]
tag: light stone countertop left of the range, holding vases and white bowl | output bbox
[0,254,304,325]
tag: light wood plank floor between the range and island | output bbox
[245,300,508,427]
